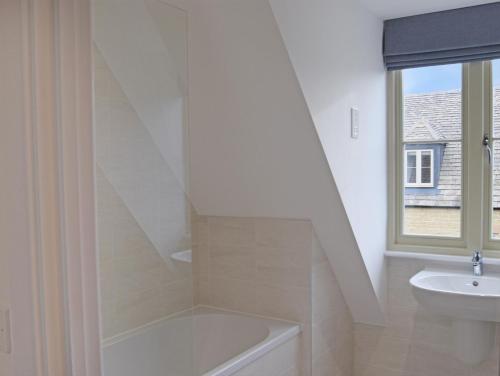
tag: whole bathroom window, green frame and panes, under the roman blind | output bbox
[388,60,500,254]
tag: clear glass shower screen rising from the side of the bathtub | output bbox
[93,0,193,376]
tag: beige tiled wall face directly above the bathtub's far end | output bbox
[193,217,312,322]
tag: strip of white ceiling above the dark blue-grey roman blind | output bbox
[360,0,495,19]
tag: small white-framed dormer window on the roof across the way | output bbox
[405,150,434,188]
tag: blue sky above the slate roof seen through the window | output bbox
[403,60,500,94]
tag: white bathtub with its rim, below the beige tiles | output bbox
[103,307,300,376]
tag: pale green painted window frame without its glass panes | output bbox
[387,61,500,257]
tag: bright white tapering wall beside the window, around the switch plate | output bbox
[270,0,387,306]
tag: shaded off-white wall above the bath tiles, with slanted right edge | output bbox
[189,0,385,323]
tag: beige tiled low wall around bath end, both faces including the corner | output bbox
[193,215,352,376]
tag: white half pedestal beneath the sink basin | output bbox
[452,319,496,365]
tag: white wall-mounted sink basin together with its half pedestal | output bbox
[410,270,500,364]
